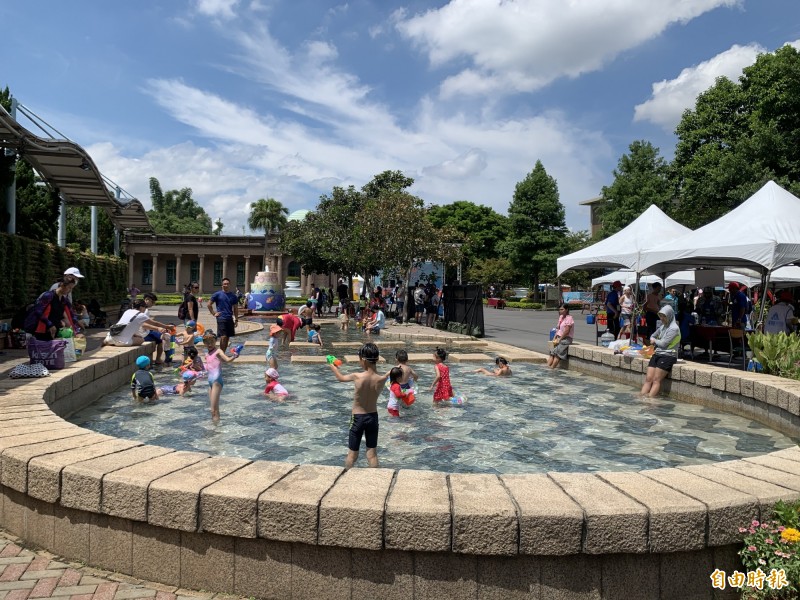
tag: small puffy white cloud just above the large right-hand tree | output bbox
[633,44,766,131]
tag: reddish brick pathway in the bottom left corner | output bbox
[0,530,247,600]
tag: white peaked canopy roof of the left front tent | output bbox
[557,204,691,274]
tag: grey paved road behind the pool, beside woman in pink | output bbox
[476,306,605,352]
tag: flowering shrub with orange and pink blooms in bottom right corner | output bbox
[739,501,800,600]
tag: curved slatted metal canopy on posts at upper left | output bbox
[0,106,152,230]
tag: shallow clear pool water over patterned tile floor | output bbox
[70,318,795,473]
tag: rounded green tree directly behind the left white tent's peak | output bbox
[600,140,672,238]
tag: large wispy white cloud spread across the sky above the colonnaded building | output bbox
[90,13,612,233]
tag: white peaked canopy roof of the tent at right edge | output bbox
[640,181,800,274]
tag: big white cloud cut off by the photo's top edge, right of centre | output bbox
[392,0,741,98]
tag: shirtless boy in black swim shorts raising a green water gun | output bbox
[330,343,389,469]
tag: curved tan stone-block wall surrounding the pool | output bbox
[0,345,800,599]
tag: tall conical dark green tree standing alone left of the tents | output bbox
[507,160,567,295]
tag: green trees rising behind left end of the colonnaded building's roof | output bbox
[147,177,212,235]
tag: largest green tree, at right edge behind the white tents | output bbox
[672,46,800,228]
